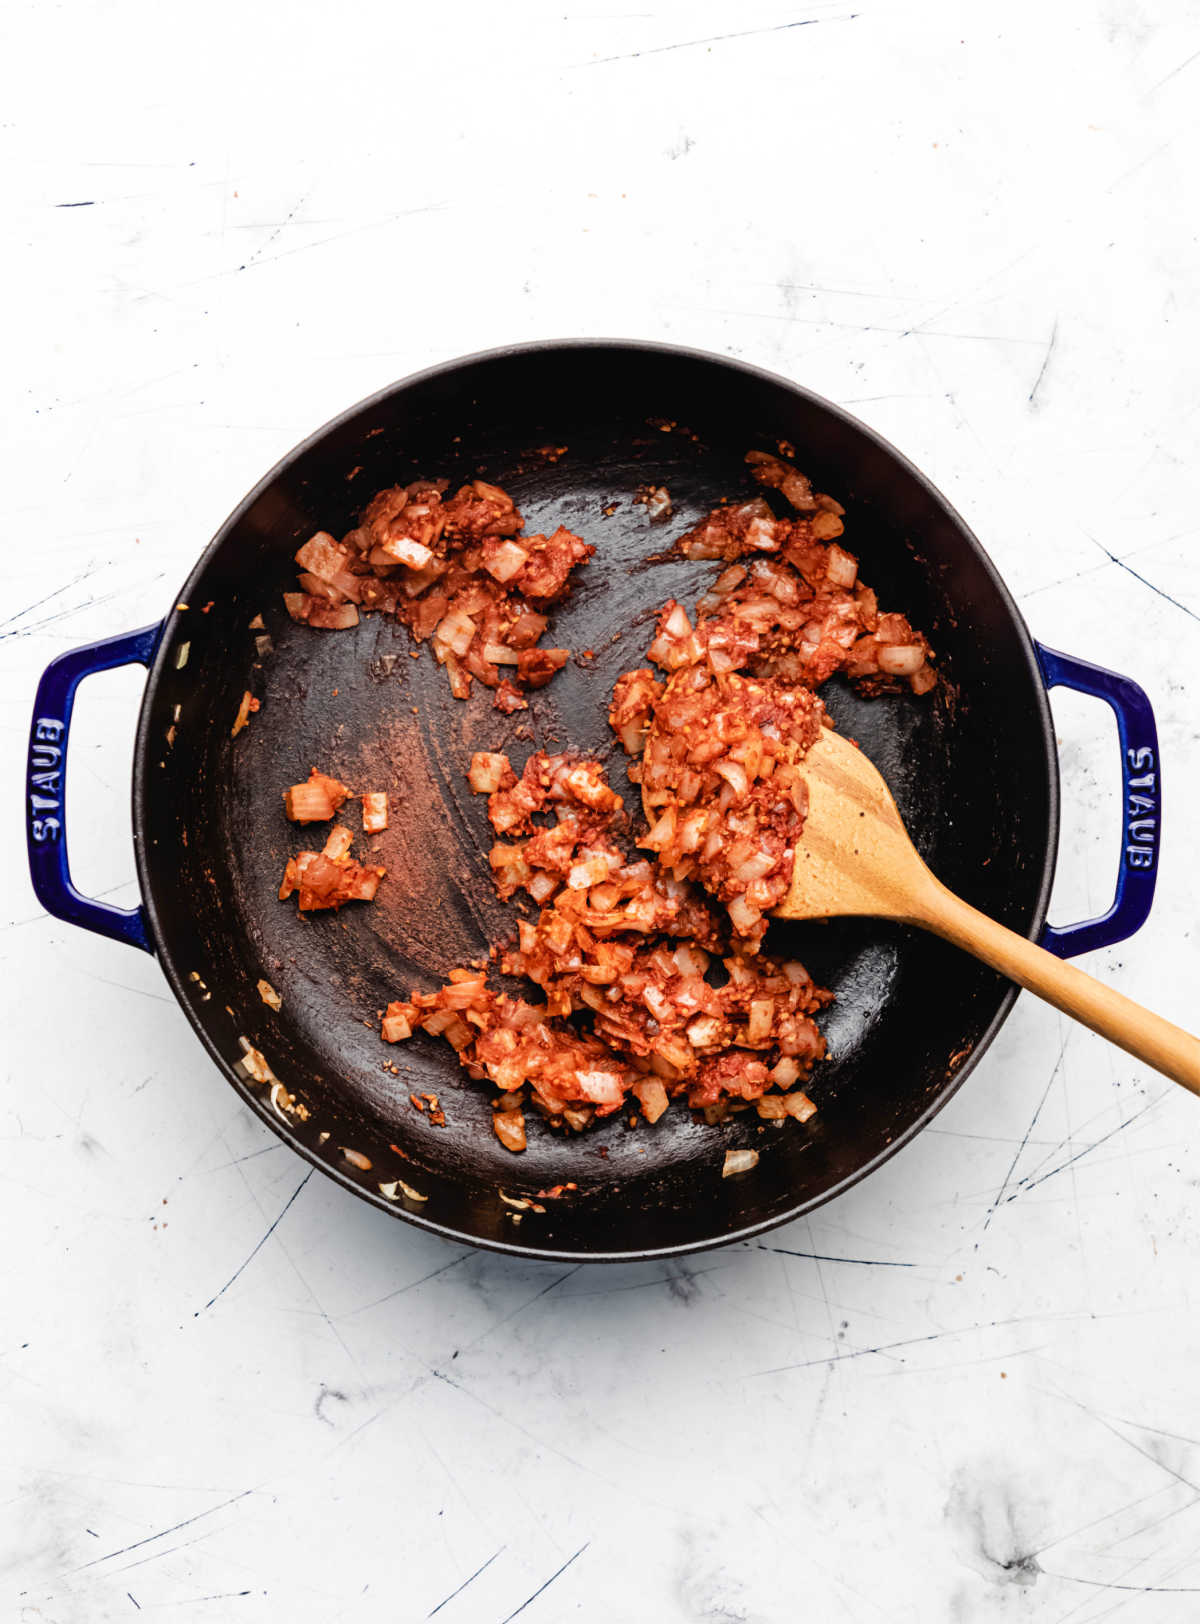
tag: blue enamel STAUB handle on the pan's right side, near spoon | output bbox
[1036,643,1163,958]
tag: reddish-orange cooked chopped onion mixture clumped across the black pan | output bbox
[279,451,937,1151]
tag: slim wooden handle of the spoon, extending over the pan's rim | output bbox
[916,875,1200,1095]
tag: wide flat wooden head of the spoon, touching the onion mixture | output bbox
[775,728,930,919]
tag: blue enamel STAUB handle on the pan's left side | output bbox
[26,624,162,953]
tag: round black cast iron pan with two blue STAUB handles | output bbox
[21,341,1158,1259]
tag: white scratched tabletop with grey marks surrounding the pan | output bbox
[0,0,1200,1624]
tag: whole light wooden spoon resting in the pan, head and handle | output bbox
[652,728,1200,1095]
